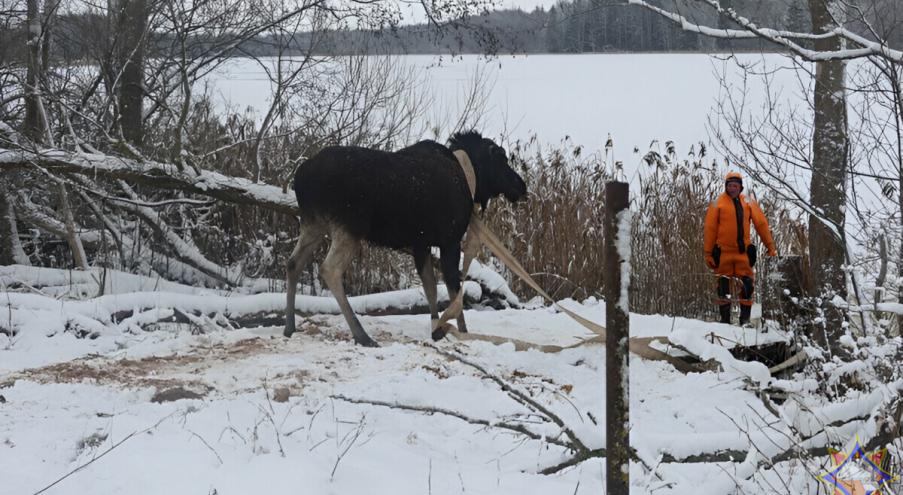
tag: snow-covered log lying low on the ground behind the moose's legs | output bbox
[0,265,482,337]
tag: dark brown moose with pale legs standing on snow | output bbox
[285,131,527,346]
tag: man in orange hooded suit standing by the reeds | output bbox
[703,172,777,325]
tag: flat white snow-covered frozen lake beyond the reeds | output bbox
[207,54,805,164]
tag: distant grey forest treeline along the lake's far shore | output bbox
[7,0,903,62]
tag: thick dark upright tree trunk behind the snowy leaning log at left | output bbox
[117,0,148,147]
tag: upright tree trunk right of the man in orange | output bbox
[809,0,849,350]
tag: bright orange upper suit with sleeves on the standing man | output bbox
[703,193,777,257]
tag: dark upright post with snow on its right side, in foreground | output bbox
[603,182,630,495]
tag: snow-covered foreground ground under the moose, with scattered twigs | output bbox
[0,267,896,495]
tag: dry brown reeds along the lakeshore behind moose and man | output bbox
[118,102,806,318]
